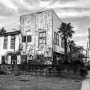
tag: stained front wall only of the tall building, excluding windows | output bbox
[20,11,52,57]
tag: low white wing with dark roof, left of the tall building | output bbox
[0,31,20,64]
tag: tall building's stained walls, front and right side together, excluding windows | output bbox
[20,10,64,62]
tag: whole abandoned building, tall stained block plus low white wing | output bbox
[0,10,64,64]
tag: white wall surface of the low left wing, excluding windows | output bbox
[0,35,20,64]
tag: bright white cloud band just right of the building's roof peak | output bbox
[51,8,90,18]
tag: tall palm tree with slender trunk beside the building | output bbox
[58,22,74,62]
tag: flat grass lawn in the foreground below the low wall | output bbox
[0,75,82,90]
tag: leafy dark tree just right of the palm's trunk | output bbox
[68,40,84,62]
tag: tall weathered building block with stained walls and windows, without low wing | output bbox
[20,10,64,64]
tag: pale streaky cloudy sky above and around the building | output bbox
[0,0,90,48]
